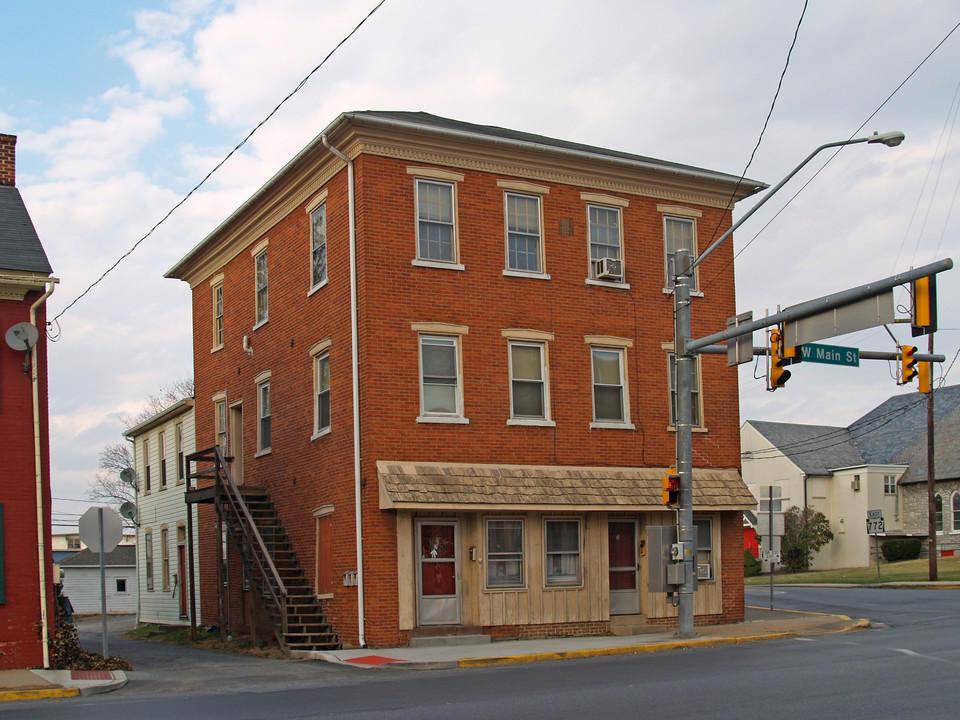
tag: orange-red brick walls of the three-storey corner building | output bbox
[188,156,742,645]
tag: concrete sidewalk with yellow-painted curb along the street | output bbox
[0,606,870,702]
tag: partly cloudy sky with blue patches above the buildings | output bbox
[0,0,960,532]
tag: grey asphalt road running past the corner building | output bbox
[2,588,960,720]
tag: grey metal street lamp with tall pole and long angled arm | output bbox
[673,131,905,637]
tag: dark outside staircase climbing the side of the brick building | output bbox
[186,447,340,654]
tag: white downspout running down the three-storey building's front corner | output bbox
[320,133,367,647]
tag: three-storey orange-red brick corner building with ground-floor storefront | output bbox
[167,112,758,649]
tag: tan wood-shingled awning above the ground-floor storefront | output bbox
[377,461,757,512]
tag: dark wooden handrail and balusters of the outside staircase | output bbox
[187,446,287,636]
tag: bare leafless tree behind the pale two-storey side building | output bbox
[87,377,193,508]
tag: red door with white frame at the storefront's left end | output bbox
[417,520,460,625]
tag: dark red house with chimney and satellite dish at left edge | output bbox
[0,134,57,669]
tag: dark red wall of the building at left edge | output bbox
[0,292,54,669]
